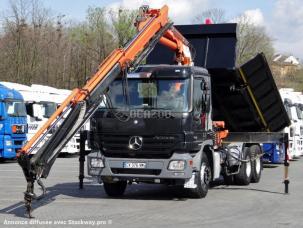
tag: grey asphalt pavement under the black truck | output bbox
[0,157,303,228]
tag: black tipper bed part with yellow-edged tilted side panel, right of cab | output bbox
[209,54,290,132]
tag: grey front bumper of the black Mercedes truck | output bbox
[87,152,193,181]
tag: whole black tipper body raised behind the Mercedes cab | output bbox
[147,24,290,132]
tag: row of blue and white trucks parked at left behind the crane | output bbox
[0,82,79,159]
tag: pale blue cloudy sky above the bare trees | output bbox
[0,0,303,59]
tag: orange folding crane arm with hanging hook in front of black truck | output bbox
[17,6,193,218]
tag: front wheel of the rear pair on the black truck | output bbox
[234,148,252,185]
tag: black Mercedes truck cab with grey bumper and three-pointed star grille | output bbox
[88,65,213,196]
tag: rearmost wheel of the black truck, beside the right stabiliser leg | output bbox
[250,145,263,183]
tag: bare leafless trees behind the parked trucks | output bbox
[0,0,273,89]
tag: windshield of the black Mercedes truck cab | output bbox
[104,79,189,112]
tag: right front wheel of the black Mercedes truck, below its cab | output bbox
[188,153,212,199]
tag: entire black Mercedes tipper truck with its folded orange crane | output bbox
[18,6,289,217]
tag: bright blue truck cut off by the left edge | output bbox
[0,84,27,160]
